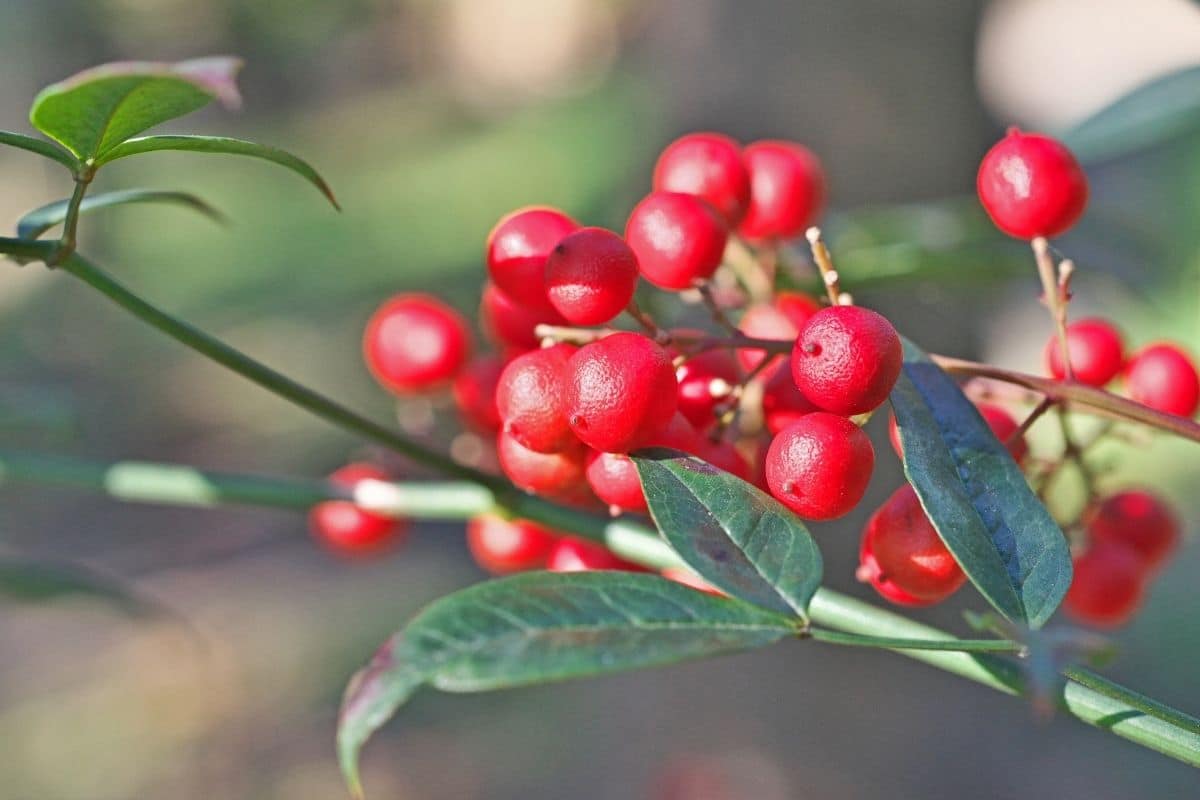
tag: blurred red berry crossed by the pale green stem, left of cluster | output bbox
[308,463,408,557]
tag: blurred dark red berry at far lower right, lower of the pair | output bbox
[1062,543,1146,628]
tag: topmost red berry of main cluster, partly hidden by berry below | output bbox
[654,133,750,225]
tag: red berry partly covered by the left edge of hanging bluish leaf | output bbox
[859,483,966,606]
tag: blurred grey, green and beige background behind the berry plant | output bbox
[0,0,1200,800]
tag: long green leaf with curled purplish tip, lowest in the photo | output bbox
[337,572,797,795]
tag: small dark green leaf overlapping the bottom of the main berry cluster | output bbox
[634,450,822,618]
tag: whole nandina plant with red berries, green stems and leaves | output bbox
[0,59,1200,795]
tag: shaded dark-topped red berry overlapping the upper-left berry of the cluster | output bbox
[546,228,637,325]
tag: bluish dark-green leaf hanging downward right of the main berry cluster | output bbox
[892,339,1072,627]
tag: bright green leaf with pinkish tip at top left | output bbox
[29,56,241,162]
